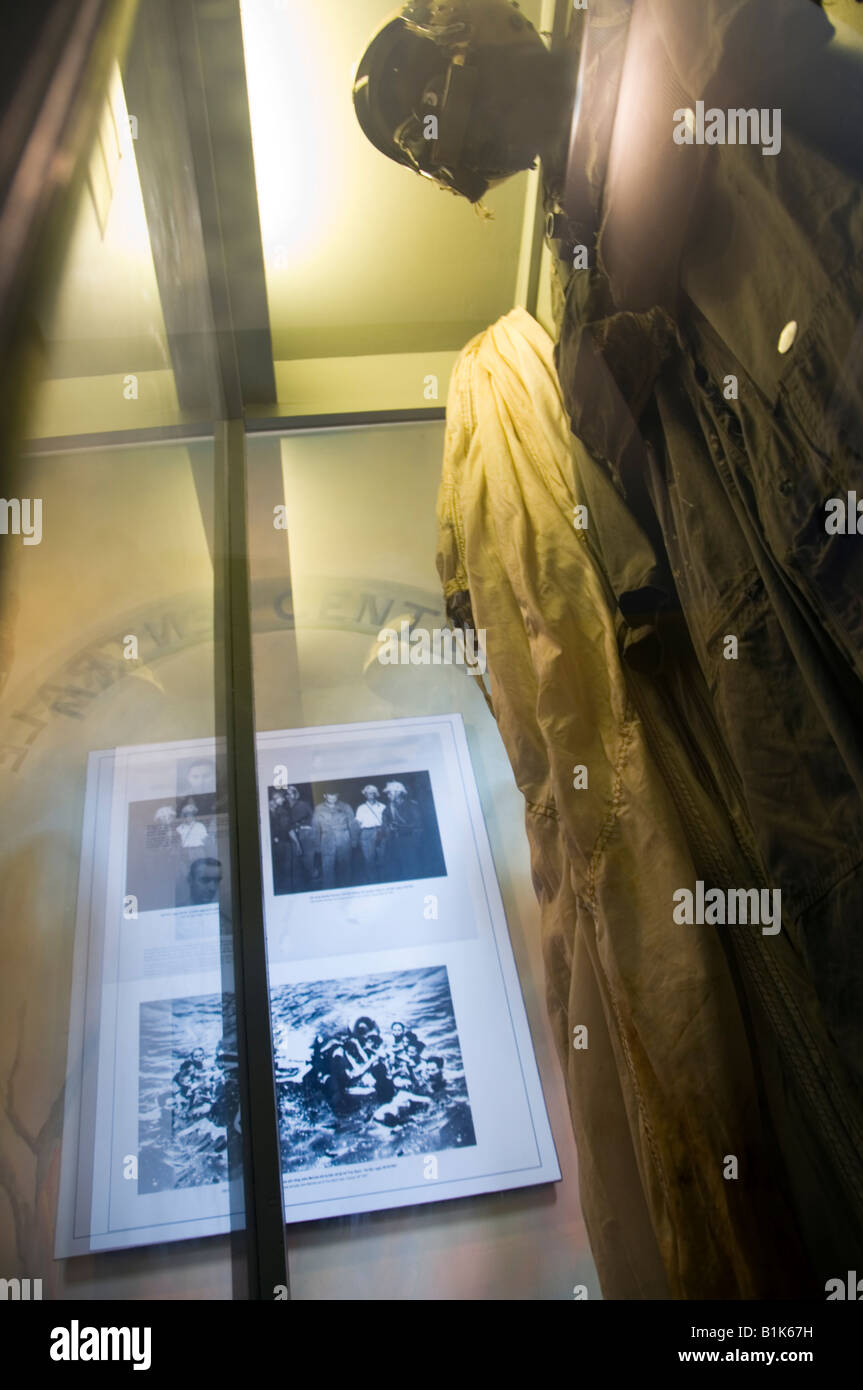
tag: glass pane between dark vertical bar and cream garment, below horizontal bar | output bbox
[249,423,599,1300]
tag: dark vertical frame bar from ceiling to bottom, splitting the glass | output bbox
[122,0,288,1300]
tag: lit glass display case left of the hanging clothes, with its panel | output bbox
[0,0,599,1300]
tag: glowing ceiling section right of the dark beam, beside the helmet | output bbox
[240,0,539,359]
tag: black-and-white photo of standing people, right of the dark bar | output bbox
[267,771,446,897]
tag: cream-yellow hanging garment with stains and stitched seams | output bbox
[438,310,814,1298]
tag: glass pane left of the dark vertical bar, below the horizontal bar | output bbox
[0,430,248,1298]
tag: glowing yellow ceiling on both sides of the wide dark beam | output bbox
[32,0,541,436]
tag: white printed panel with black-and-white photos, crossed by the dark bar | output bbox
[57,716,560,1255]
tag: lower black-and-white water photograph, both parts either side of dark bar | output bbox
[138,966,477,1194]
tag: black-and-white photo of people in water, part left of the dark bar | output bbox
[138,994,239,1194]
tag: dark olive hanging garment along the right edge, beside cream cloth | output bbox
[546,0,863,1279]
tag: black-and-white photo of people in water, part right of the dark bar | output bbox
[271,966,477,1175]
